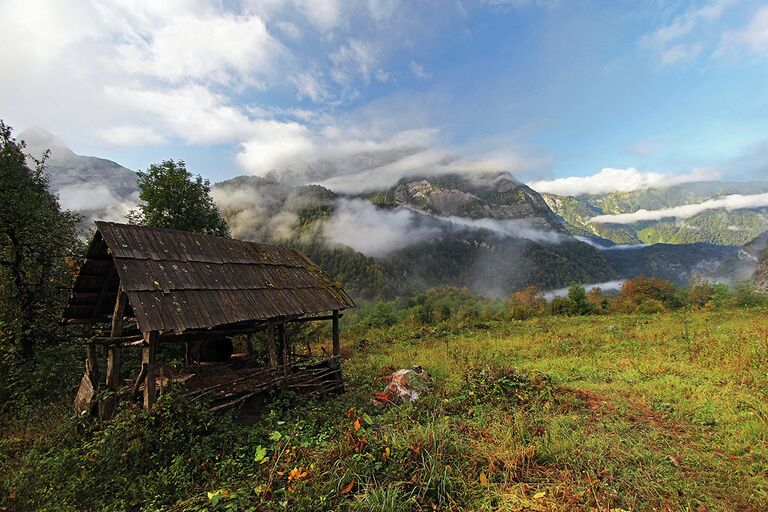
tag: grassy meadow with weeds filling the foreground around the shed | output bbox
[0,310,768,511]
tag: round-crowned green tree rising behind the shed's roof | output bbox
[129,160,230,237]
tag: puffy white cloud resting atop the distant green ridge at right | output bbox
[528,167,720,196]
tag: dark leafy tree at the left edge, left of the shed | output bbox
[0,121,81,360]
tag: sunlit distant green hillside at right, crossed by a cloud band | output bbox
[542,182,768,245]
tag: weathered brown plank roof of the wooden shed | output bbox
[63,222,354,334]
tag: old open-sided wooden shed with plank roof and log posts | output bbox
[63,222,354,416]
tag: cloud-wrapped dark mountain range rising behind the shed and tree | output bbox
[15,126,760,297]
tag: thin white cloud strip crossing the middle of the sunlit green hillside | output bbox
[590,193,768,224]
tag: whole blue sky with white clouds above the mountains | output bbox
[0,0,768,190]
